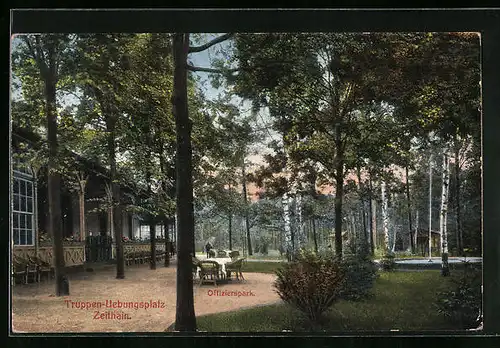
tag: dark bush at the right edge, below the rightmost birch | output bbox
[436,268,482,329]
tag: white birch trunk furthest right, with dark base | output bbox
[439,149,450,276]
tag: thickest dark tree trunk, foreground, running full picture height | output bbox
[172,33,196,332]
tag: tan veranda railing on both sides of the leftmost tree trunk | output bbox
[13,243,85,266]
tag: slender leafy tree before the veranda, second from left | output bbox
[74,34,139,279]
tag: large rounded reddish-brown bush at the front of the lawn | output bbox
[274,252,344,323]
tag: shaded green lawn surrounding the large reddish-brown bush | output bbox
[197,270,464,332]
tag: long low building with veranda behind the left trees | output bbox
[11,125,172,265]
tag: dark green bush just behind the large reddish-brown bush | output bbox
[340,255,378,301]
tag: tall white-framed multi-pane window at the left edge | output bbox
[12,177,35,245]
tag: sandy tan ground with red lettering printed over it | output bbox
[12,265,280,333]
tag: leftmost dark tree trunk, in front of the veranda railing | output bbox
[45,74,69,296]
